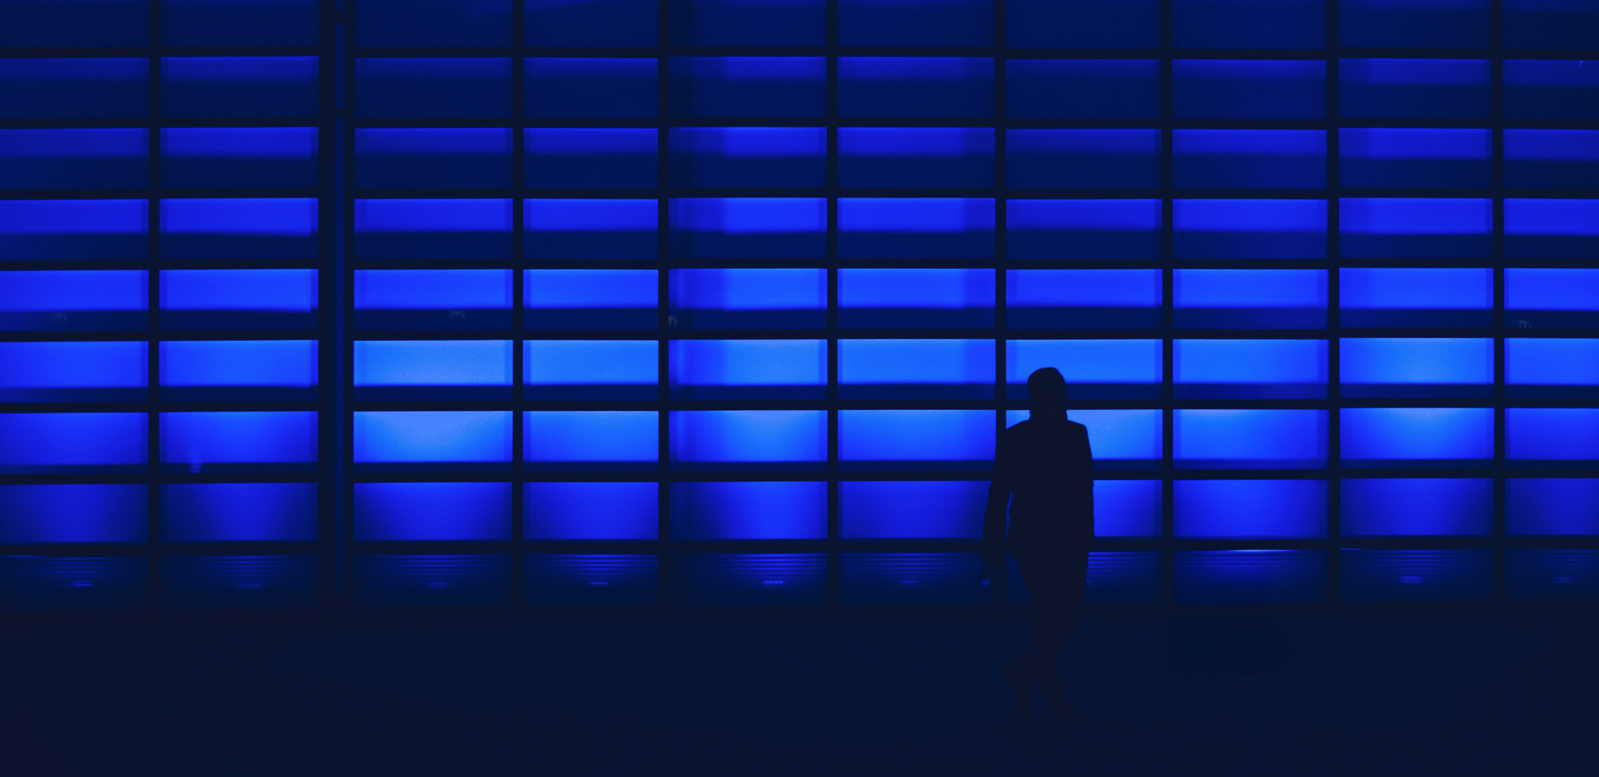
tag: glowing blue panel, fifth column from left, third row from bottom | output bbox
[667,411,827,470]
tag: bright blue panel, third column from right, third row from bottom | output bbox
[1172,409,1323,470]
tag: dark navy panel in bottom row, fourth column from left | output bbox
[523,553,660,608]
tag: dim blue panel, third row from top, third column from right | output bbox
[1172,130,1327,189]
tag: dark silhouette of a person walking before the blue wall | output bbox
[983,368,1094,719]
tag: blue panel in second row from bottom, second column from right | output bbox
[1338,478,1493,537]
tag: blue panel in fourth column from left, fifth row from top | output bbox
[521,270,660,329]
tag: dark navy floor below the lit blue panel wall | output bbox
[0,614,1599,777]
